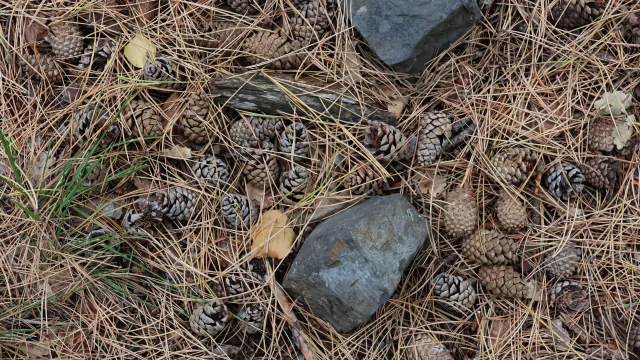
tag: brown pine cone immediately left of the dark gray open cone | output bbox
[491,147,537,185]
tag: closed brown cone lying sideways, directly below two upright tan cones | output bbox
[462,229,518,265]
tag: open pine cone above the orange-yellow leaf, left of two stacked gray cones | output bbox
[242,141,280,187]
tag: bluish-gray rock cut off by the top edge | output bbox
[344,0,482,74]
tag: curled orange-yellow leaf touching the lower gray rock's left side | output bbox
[249,210,296,259]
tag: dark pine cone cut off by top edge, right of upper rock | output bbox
[551,0,606,30]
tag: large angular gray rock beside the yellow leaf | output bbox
[283,194,428,331]
